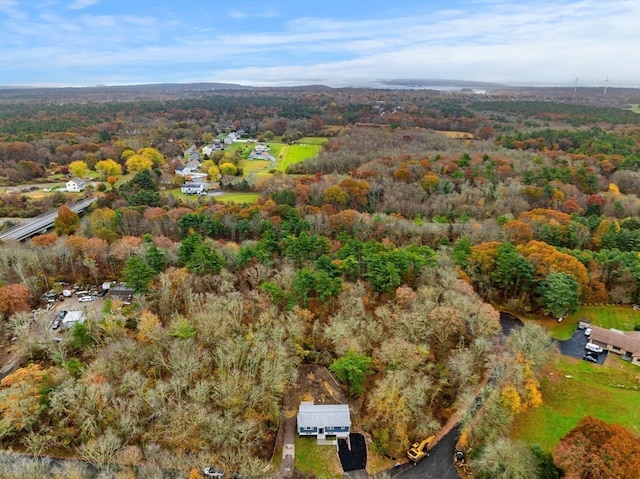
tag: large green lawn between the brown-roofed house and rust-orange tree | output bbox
[512,355,640,451]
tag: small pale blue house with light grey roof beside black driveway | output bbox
[298,401,351,440]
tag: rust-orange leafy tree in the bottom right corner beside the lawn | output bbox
[553,416,640,479]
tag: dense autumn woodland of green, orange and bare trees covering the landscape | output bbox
[0,84,640,478]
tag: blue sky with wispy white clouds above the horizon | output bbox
[0,0,640,88]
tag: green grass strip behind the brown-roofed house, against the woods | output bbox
[544,306,640,340]
